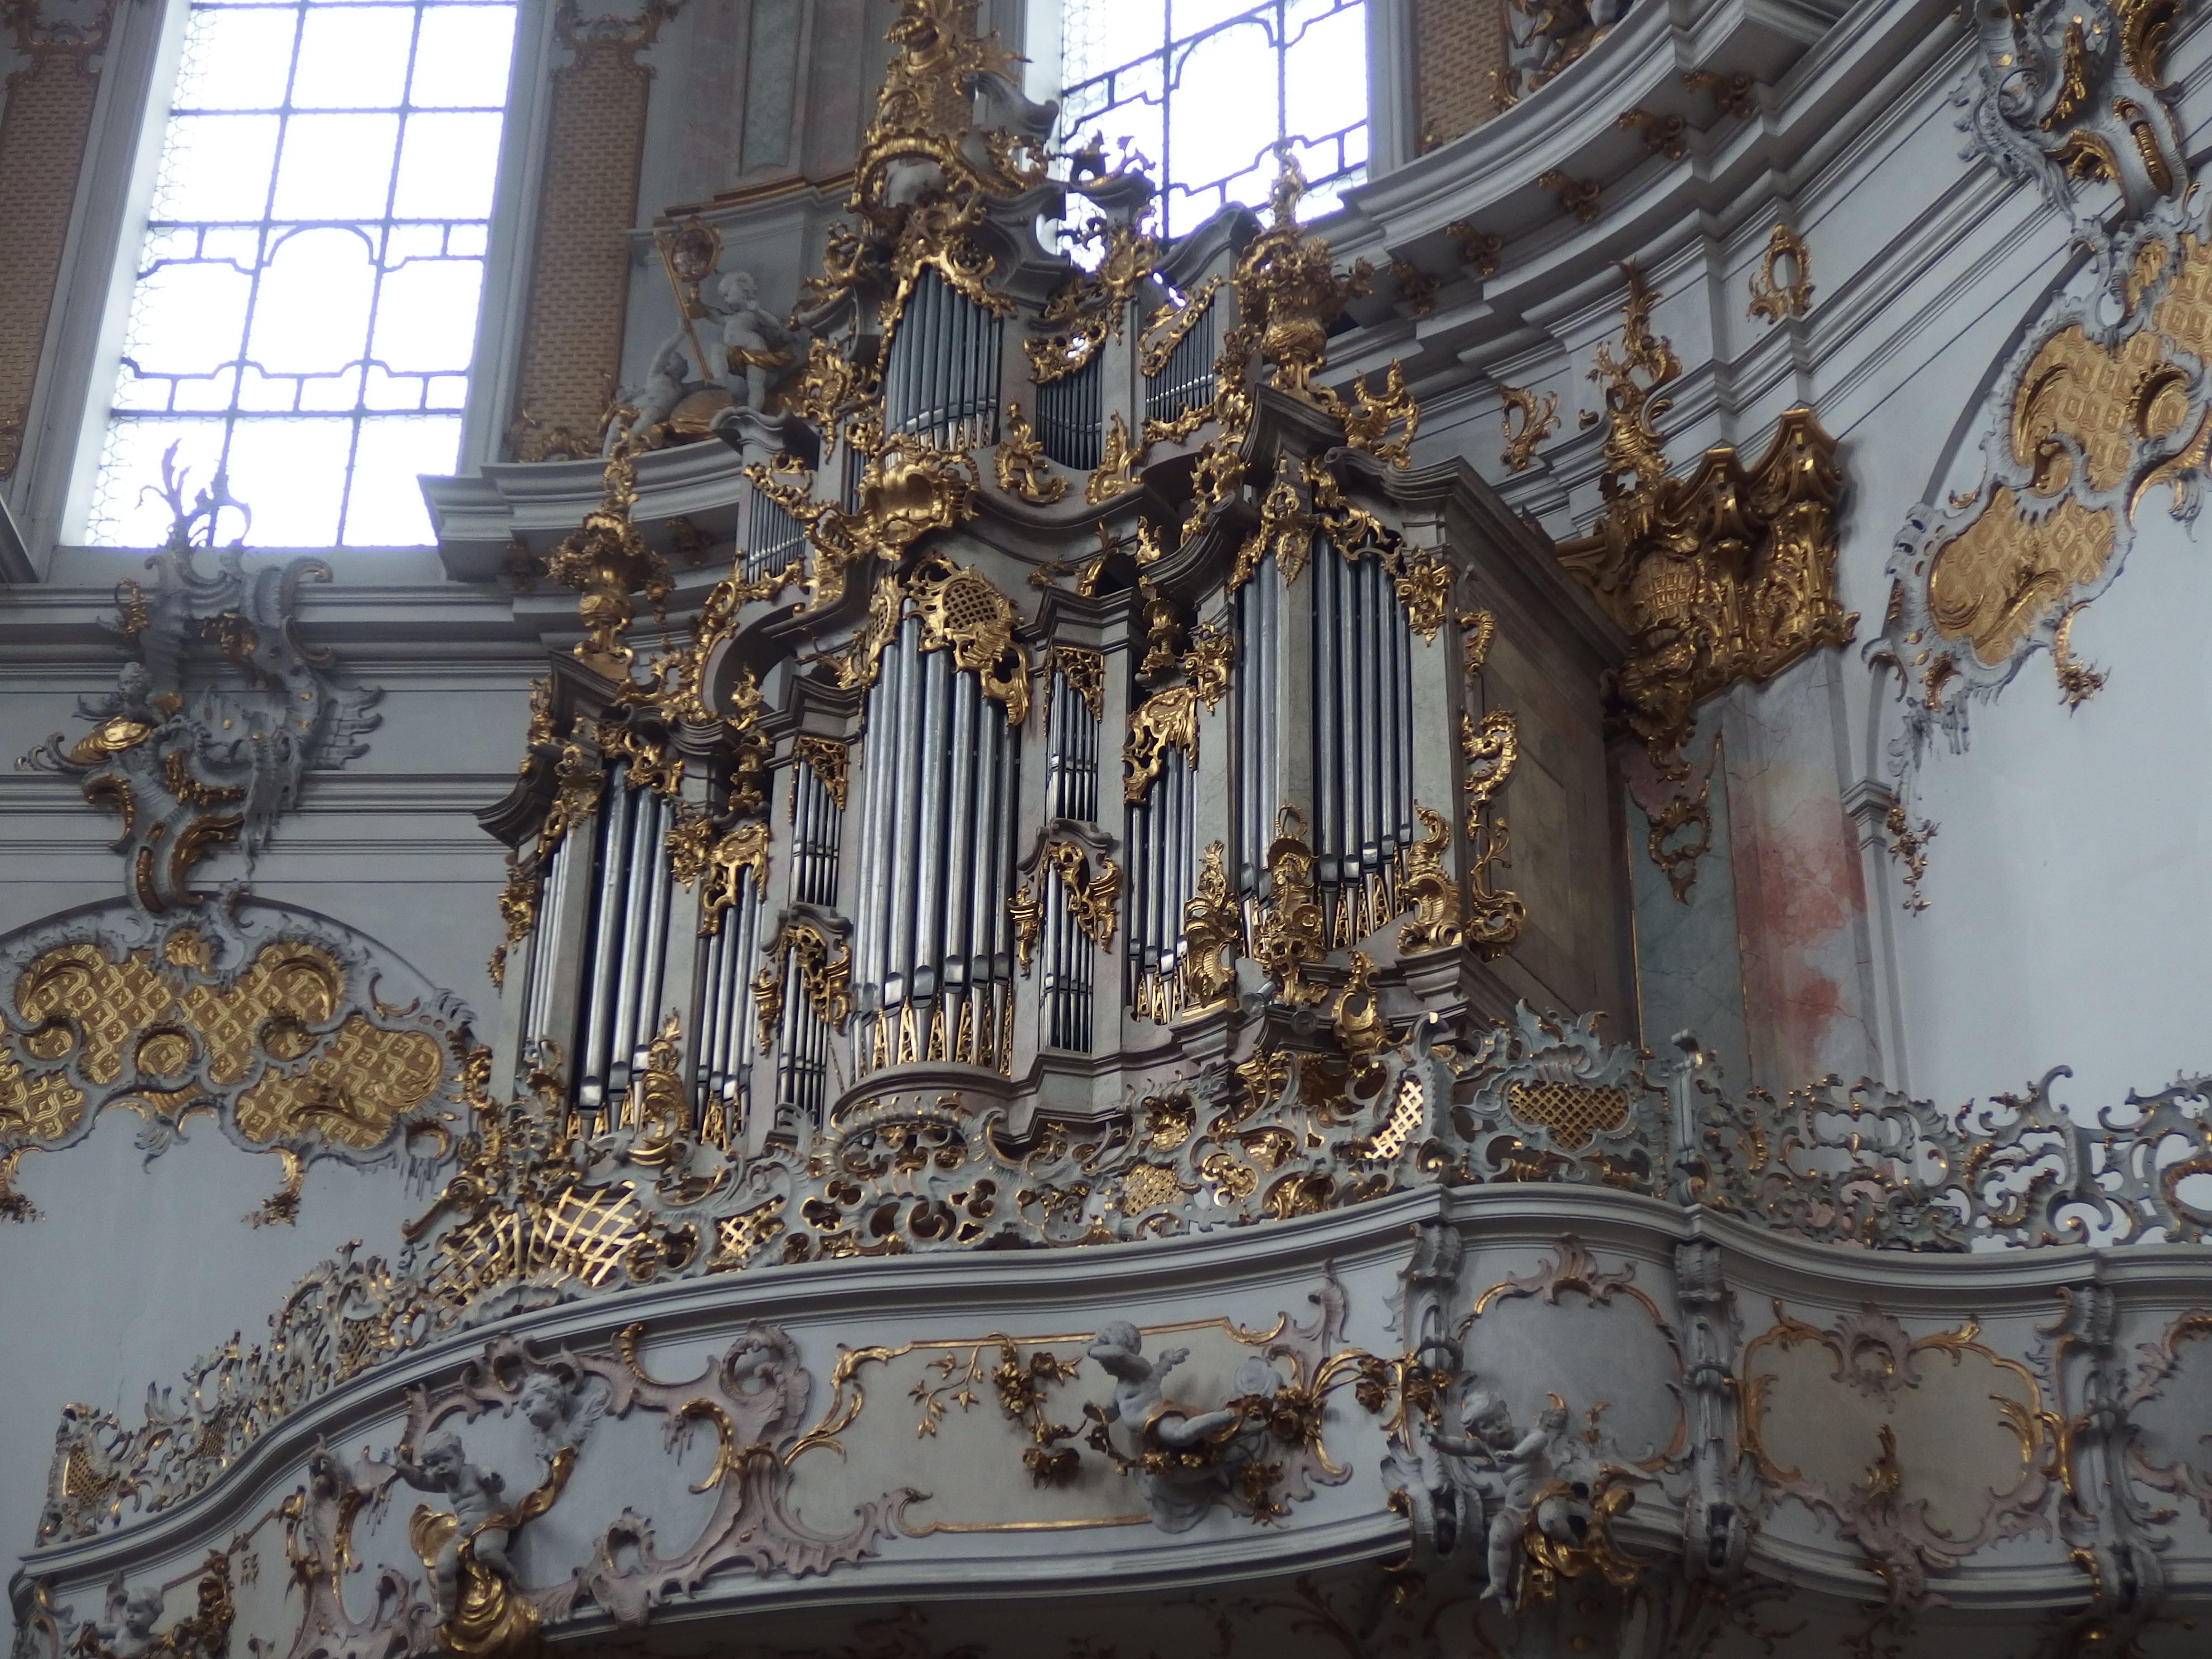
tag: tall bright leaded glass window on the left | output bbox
[89,0,516,546]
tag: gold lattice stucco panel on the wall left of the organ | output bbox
[0,911,467,1221]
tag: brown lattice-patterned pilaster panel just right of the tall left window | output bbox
[509,26,666,460]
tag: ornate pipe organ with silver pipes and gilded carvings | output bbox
[487,19,1617,1159]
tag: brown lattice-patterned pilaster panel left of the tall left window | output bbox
[0,32,106,478]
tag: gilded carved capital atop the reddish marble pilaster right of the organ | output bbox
[1559,268,1858,777]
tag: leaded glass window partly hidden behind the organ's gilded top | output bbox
[1060,0,1367,237]
